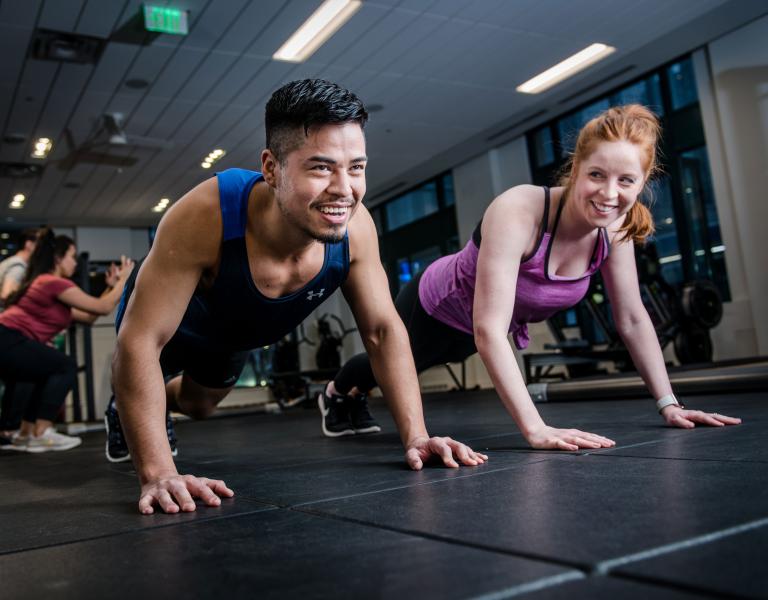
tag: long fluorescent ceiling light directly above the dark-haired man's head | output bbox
[272,0,363,62]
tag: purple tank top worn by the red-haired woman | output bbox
[419,187,610,350]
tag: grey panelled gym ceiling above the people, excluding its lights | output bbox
[0,0,768,226]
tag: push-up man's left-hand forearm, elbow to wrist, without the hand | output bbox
[114,347,177,484]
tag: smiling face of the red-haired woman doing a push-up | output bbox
[573,141,645,227]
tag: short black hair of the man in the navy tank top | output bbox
[264,79,368,162]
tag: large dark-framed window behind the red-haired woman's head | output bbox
[527,52,730,300]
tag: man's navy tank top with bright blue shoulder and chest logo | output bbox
[171,169,349,351]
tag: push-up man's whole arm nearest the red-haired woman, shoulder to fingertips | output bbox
[343,206,487,470]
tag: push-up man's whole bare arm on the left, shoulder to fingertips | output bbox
[112,179,232,514]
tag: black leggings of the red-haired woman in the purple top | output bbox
[333,274,477,394]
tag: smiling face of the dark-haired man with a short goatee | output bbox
[262,123,367,243]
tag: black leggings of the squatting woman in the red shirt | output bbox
[0,325,77,423]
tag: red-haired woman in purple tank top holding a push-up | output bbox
[318,104,740,450]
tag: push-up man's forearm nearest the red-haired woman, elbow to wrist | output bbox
[367,325,428,448]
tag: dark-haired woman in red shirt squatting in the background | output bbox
[0,229,133,452]
